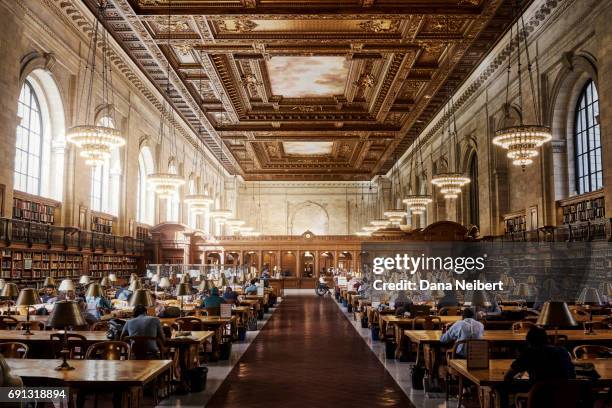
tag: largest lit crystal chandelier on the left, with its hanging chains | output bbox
[66,1,125,166]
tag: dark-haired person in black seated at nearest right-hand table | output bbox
[504,326,576,383]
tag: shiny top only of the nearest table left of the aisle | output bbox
[6,358,172,386]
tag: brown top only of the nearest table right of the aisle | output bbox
[449,359,612,386]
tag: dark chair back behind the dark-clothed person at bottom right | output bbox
[516,381,580,408]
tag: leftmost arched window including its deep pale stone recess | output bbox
[13,73,65,201]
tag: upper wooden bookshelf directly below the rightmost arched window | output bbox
[557,190,606,224]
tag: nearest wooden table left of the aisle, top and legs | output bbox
[6,358,172,408]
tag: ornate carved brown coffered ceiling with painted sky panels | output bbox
[83,0,531,180]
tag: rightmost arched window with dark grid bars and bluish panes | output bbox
[574,80,603,194]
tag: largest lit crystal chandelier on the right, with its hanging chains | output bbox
[492,5,552,170]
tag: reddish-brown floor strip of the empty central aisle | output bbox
[206,296,414,407]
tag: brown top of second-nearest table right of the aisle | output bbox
[404,330,612,344]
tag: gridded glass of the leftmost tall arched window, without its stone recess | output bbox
[15,80,43,195]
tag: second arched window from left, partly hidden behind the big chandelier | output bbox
[90,116,121,215]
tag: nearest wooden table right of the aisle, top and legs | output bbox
[449,359,612,408]
